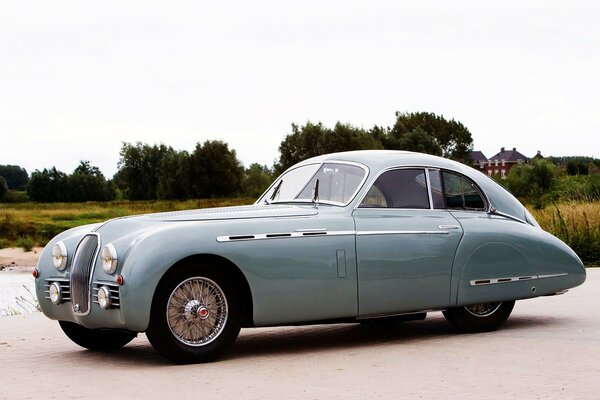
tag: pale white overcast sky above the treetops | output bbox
[0,0,600,177]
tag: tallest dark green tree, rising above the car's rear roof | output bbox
[390,111,473,163]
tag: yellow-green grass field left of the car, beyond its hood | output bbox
[0,198,254,248]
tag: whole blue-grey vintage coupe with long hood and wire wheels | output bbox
[34,151,586,363]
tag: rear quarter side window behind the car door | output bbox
[436,171,485,211]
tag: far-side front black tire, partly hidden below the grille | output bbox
[58,321,137,351]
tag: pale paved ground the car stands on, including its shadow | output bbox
[0,269,600,400]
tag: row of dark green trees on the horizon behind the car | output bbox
[0,112,473,202]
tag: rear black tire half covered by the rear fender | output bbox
[443,301,515,333]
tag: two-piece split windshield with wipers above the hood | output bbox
[259,163,366,204]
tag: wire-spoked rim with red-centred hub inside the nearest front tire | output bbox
[167,277,228,346]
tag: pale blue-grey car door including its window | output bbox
[353,167,463,317]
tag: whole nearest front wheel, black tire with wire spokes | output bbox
[146,265,242,364]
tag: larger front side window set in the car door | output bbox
[359,169,429,209]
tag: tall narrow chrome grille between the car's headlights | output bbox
[71,235,99,314]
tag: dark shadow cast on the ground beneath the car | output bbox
[63,314,569,366]
